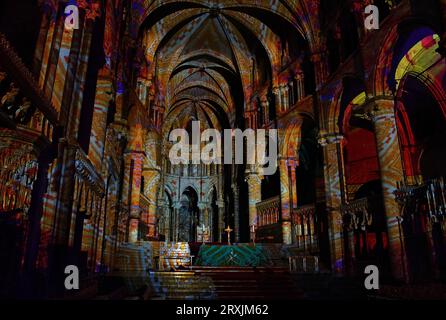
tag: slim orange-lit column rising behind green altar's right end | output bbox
[279,158,293,244]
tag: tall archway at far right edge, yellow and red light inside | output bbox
[388,23,446,283]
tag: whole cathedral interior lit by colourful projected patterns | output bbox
[0,0,446,298]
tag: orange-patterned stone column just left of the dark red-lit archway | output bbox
[319,134,345,273]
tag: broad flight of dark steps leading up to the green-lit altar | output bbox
[146,267,303,300]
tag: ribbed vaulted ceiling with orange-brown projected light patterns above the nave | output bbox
[141,1,312,136]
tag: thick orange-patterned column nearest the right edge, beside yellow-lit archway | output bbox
[366,97,407,280]
